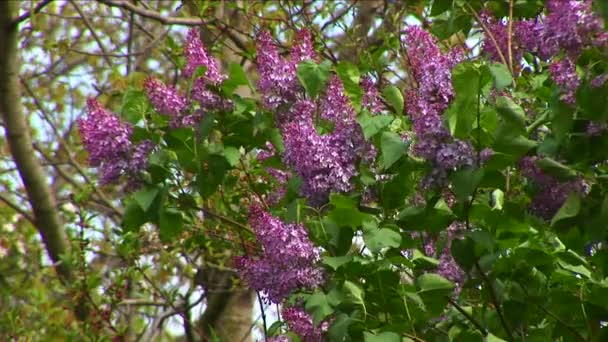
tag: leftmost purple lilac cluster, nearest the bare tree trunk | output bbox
[78,98,154,189]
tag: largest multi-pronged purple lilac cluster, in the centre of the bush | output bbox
[257,30,372,205]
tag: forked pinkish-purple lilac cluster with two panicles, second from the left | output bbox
[144,28,231,128]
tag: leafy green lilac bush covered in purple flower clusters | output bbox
[3,0,608,342]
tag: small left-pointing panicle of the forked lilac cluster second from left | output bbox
[144,77,188,115]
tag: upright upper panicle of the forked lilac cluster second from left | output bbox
[183,28,226,84]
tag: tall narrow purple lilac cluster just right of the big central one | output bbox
[405,26,474,187]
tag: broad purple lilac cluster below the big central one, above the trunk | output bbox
[235,205,324,303]
